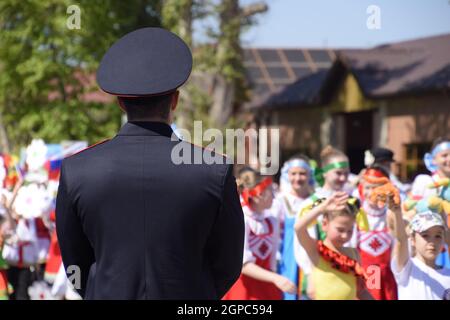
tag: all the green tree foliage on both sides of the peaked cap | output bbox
[0,0,266,151]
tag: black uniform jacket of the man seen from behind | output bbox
[56,122,244,299]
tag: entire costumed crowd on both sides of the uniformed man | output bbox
[0,139,450,300]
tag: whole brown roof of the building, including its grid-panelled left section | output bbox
[248,34,450,109]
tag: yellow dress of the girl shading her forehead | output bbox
[311,252,357,300]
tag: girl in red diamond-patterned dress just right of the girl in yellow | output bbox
[358,167,397,300]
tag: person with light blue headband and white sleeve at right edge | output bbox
[410,138,450,268]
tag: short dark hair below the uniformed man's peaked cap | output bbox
[117,93,173,119]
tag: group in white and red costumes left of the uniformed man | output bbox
[0,139,86,300]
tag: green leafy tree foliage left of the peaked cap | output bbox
[0,0,161,150]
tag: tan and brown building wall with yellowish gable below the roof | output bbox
[327,74,450,178]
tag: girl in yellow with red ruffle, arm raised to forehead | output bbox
[295,192,372,300]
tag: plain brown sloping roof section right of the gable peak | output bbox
[339,34,450,97]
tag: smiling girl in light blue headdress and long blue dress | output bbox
[271,156,313,300]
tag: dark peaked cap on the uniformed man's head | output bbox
[97,28,192,97]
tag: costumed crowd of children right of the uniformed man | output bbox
[224,139,450,300]
